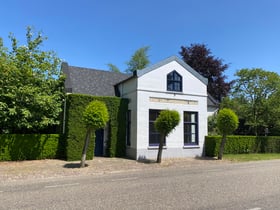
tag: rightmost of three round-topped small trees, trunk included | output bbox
[217,108,238,160]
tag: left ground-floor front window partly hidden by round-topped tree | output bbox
[149,109,165,146]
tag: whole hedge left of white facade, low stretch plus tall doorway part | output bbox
[0,94,128,161]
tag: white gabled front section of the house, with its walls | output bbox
[118,57,208,159]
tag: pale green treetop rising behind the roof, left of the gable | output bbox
[126,46,150,73]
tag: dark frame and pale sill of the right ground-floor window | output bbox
[183,111,199,146]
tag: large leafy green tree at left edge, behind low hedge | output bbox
[0,27,64,133]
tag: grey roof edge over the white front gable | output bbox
[134,56,208,85]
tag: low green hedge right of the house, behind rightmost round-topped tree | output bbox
[205,136,280,157]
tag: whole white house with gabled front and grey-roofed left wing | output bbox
[62,56,218,159]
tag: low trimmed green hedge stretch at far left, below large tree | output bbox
[0,134,60,161]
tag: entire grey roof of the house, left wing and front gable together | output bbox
[61,56,219,107]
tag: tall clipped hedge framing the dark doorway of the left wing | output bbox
[65,94,128,160]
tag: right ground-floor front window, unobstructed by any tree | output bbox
[184,112,198,145]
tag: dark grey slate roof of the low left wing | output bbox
[61,62,131,96]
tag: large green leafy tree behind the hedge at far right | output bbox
[232,68,280,136]
